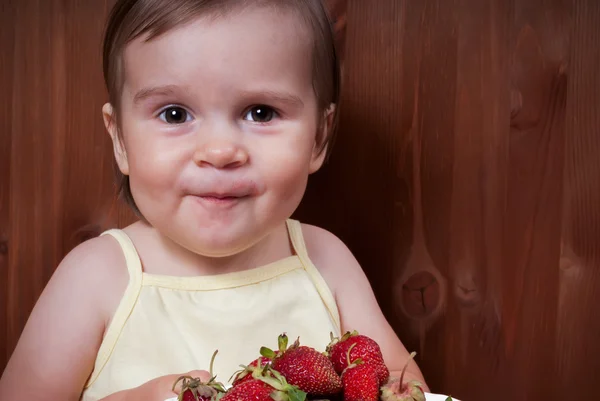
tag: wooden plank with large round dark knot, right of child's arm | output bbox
[390,0,458,392]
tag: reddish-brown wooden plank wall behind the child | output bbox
[0,0,600,401]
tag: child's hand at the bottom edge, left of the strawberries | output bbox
[102,370,210,401]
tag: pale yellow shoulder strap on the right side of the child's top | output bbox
[287,219,342,335]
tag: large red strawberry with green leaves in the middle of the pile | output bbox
[260,334,342,395]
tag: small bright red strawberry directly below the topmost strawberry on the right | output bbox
[342,360,379,401]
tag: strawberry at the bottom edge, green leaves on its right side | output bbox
[220,370,306,401]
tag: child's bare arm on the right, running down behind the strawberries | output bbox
[304,225,429,392]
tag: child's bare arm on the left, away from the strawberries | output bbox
[0,237,128,401]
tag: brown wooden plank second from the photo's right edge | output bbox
[502,0,572,400]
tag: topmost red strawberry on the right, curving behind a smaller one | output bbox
[326,331,390,386]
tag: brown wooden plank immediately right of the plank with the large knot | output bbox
[443,0,513,401]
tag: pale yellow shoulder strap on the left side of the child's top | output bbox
[85,229,142,388]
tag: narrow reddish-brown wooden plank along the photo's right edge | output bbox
[556,0,600,400]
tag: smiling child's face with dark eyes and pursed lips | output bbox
[105,4,324,256]
